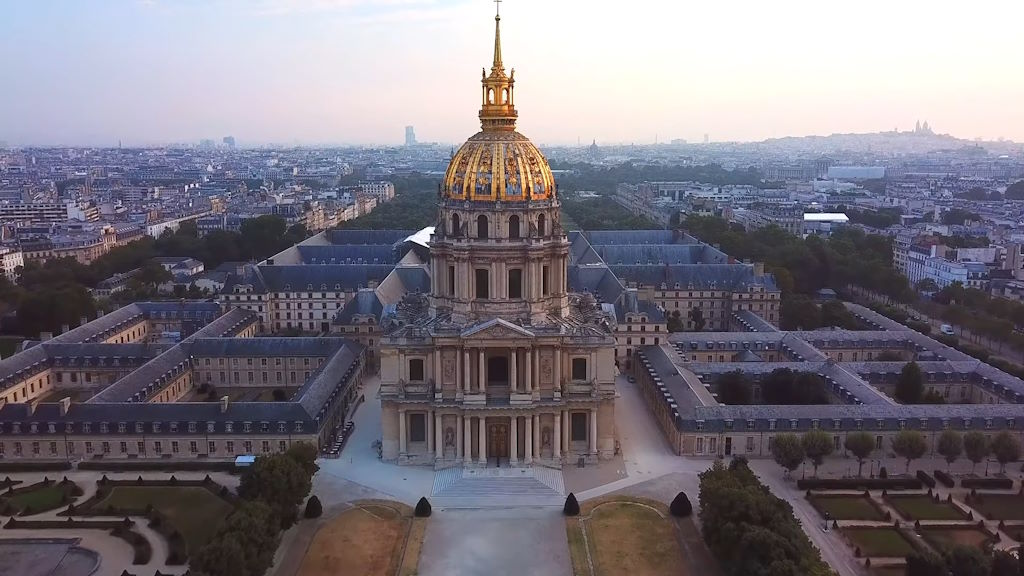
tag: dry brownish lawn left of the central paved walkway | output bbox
[298,498,416,576]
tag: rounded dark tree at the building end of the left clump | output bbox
[239,453,312,528]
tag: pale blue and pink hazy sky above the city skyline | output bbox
[0,0,1024,146]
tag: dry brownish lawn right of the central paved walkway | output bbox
[586,502,685,576]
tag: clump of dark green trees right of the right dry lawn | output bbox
[699,458,833,576]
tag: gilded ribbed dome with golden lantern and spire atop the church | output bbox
[443,0,555,202]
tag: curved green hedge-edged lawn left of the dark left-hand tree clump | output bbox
[93,486,232,553]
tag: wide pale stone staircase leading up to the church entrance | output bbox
[430,467,565,508]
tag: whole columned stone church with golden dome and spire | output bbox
[380,6,616,468]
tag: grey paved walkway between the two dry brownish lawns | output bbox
[417,507,572,576]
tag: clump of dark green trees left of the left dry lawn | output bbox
[189,443,319,576]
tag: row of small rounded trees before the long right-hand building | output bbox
[771,429,1021,476]
